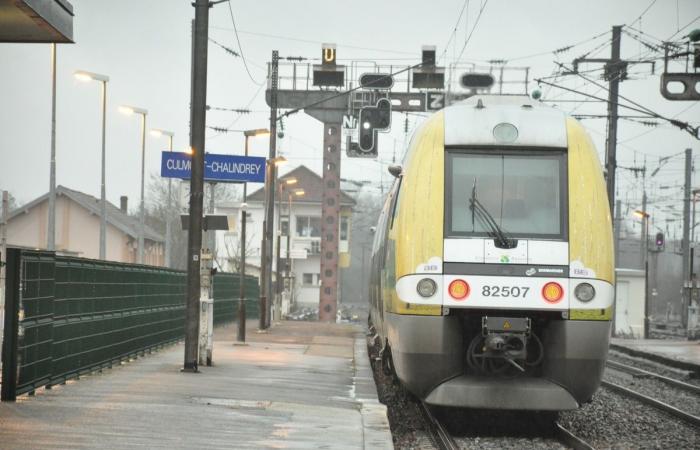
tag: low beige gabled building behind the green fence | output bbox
[7,186,165,266]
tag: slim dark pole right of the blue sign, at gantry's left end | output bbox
[260,50,279,330]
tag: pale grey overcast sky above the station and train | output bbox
[0,0,700,237]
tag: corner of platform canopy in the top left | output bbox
[0,0,73,43]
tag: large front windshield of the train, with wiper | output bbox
[446,150,566,239]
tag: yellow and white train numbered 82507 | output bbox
[369,95,615,411]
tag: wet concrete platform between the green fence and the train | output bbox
[0,322,393,449]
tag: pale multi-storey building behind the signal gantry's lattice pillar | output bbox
[216,166,355,310]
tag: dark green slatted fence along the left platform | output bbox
[2,249,259,400]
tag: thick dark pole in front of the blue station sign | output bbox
[183,0,210,372]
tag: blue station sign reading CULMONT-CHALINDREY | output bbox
[160,151,265,183]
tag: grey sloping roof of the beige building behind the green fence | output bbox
[7,186,165,242]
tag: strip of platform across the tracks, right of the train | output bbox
[610,338,700,375]
